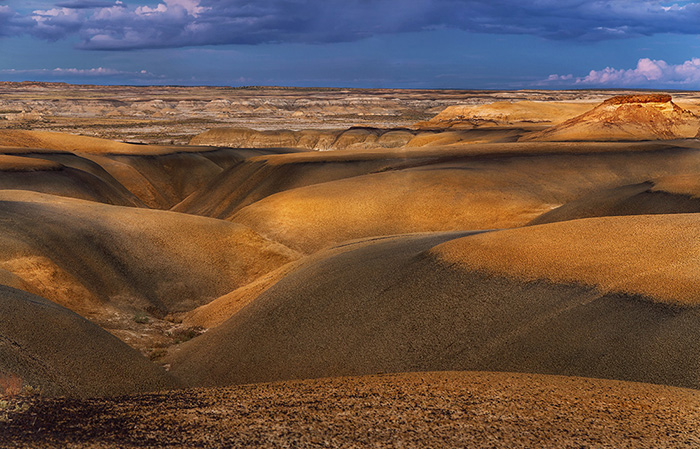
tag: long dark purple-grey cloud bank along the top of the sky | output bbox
[6,0,700,50]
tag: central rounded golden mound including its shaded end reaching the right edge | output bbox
[226,144,700,253]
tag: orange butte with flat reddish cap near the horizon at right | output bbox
[520,95,700,141]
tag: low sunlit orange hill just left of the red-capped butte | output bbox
[415,101,590,129]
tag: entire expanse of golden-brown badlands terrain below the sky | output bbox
[0,84,700,447]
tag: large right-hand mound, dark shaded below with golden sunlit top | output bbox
[169,215,700,388]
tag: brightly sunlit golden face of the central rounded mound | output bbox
[230,166,551,253]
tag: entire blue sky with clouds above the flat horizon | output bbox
[0,0,700,90]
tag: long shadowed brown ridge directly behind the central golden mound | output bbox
[173,142,684,219]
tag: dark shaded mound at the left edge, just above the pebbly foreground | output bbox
[0,285,176,396]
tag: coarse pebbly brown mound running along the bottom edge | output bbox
[5,372,700,448]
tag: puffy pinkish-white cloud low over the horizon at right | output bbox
[542,58,700,88]
